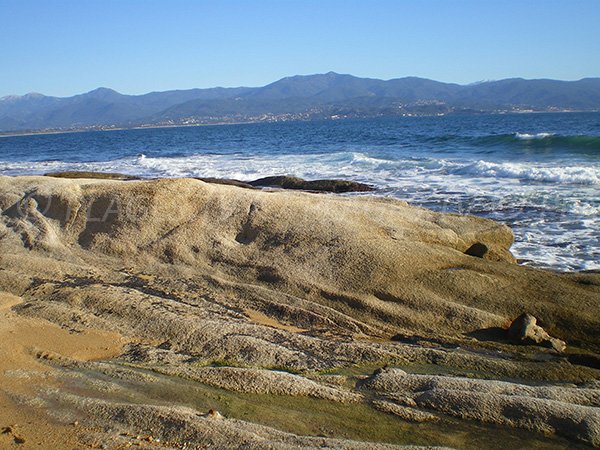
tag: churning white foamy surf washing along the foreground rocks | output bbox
[0,151,600,270]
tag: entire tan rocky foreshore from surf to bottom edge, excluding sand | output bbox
[0,176,600,448]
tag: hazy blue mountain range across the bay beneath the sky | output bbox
[0,72,600,133]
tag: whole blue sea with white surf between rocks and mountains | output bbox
[0,113,600,270]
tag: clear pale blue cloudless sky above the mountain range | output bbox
[0,0,600,97]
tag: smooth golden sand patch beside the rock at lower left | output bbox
[0,292,126,448]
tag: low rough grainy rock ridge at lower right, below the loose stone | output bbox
[362,369,600,446]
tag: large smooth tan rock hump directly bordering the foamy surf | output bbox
[0,177,600,344]
